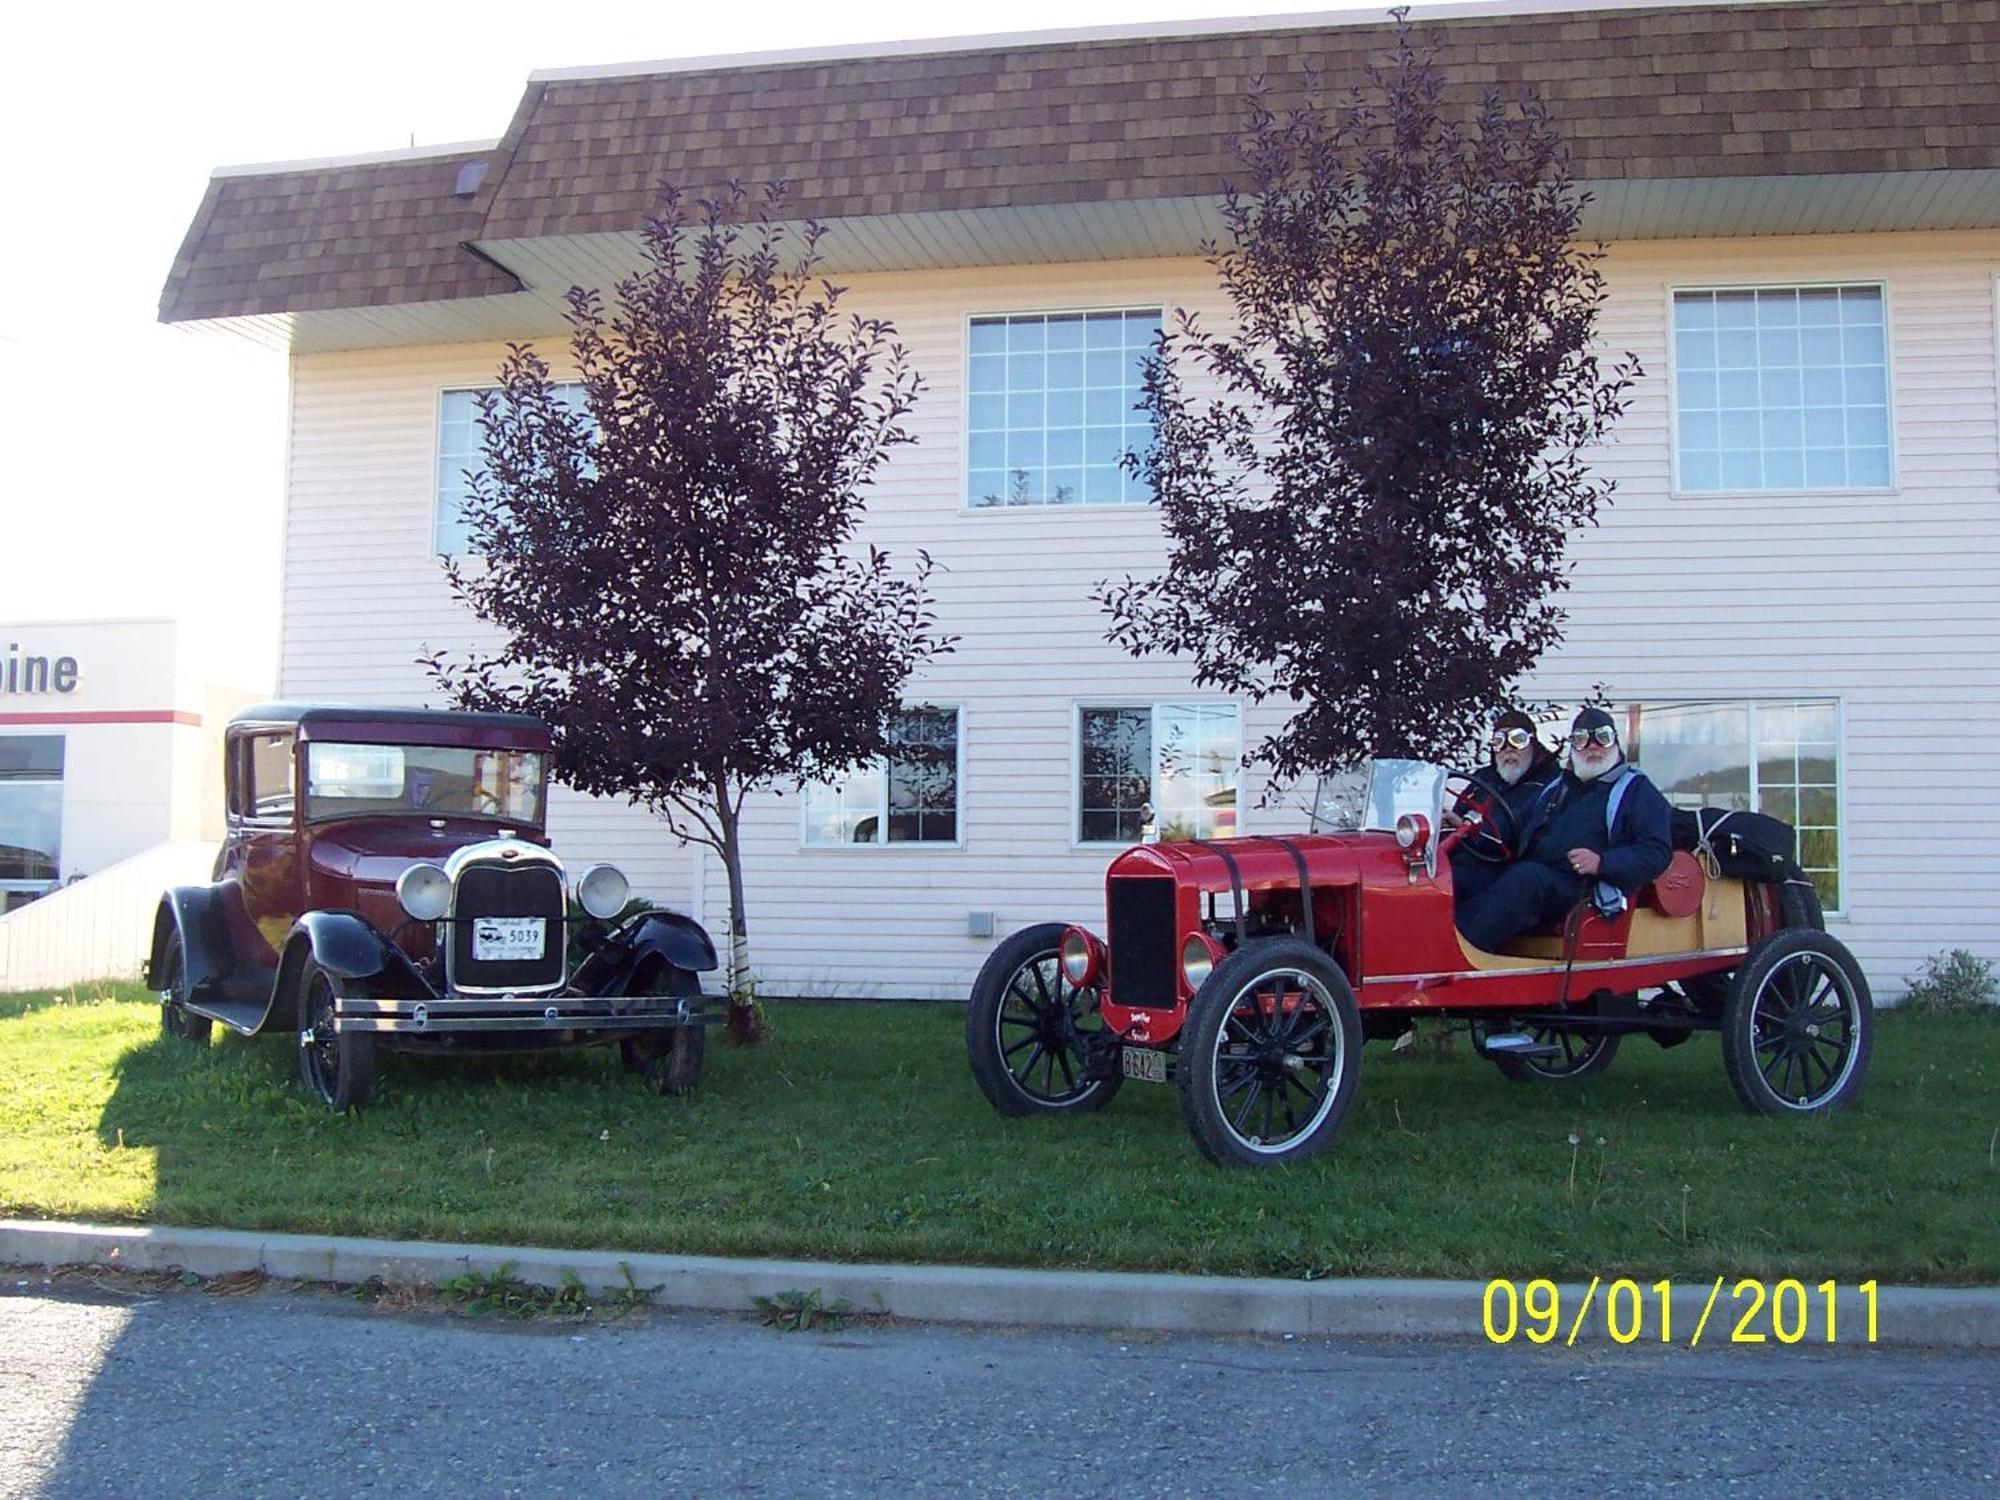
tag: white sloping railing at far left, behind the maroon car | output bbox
[0,840,216,994]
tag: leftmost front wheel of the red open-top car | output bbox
[966,922,1124,1116]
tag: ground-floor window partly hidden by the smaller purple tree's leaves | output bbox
[806,704,960,846]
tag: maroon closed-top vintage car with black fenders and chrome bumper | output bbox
[146,704,716,1110]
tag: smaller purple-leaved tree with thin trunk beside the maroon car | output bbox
[424,186,952,1040]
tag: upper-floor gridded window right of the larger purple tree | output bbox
[1674,286,1890,502]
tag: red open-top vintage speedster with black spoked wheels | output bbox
[966,760,1874,1166]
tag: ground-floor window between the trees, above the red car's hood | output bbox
[1076,702,1242,844]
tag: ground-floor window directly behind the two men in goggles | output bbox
[1624,698,1842,912]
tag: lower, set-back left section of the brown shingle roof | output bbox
[160,150,520,322]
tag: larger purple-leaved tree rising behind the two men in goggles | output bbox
[1096,24,1640,780]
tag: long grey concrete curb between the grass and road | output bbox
[0,1220,2000,1348]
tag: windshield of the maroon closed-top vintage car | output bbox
[306,742,548,828]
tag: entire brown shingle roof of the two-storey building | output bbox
[162,0,2000,320]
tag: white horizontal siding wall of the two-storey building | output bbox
[280,234,2000,996]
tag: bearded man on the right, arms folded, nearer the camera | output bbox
[1456,708,1674,952]
